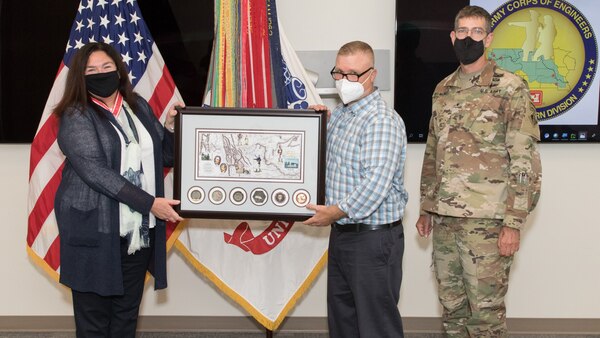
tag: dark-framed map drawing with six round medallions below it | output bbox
[173,107,327,221]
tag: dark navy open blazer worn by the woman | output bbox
[54,97,173,296]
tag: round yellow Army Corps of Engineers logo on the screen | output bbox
[488,0,598,121]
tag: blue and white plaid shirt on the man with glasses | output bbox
[325,89,408,225]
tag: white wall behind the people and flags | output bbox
[0,0,600,318]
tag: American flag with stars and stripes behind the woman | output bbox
[27,0,183,280]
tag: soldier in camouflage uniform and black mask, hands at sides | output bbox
[416,6,541,337]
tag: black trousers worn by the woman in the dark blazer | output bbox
[72,230,154,338]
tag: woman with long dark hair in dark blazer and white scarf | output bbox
[55,43,182,337]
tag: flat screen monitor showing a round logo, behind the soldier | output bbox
[394,0,600,143]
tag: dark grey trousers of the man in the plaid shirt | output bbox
[327,225,404,338]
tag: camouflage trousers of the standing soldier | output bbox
[432,215,513,338]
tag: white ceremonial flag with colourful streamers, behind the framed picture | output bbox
[176,0,329,330]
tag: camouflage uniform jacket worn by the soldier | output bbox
[421,61,542,229]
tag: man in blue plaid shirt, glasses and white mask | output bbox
[304,41,408,338]
